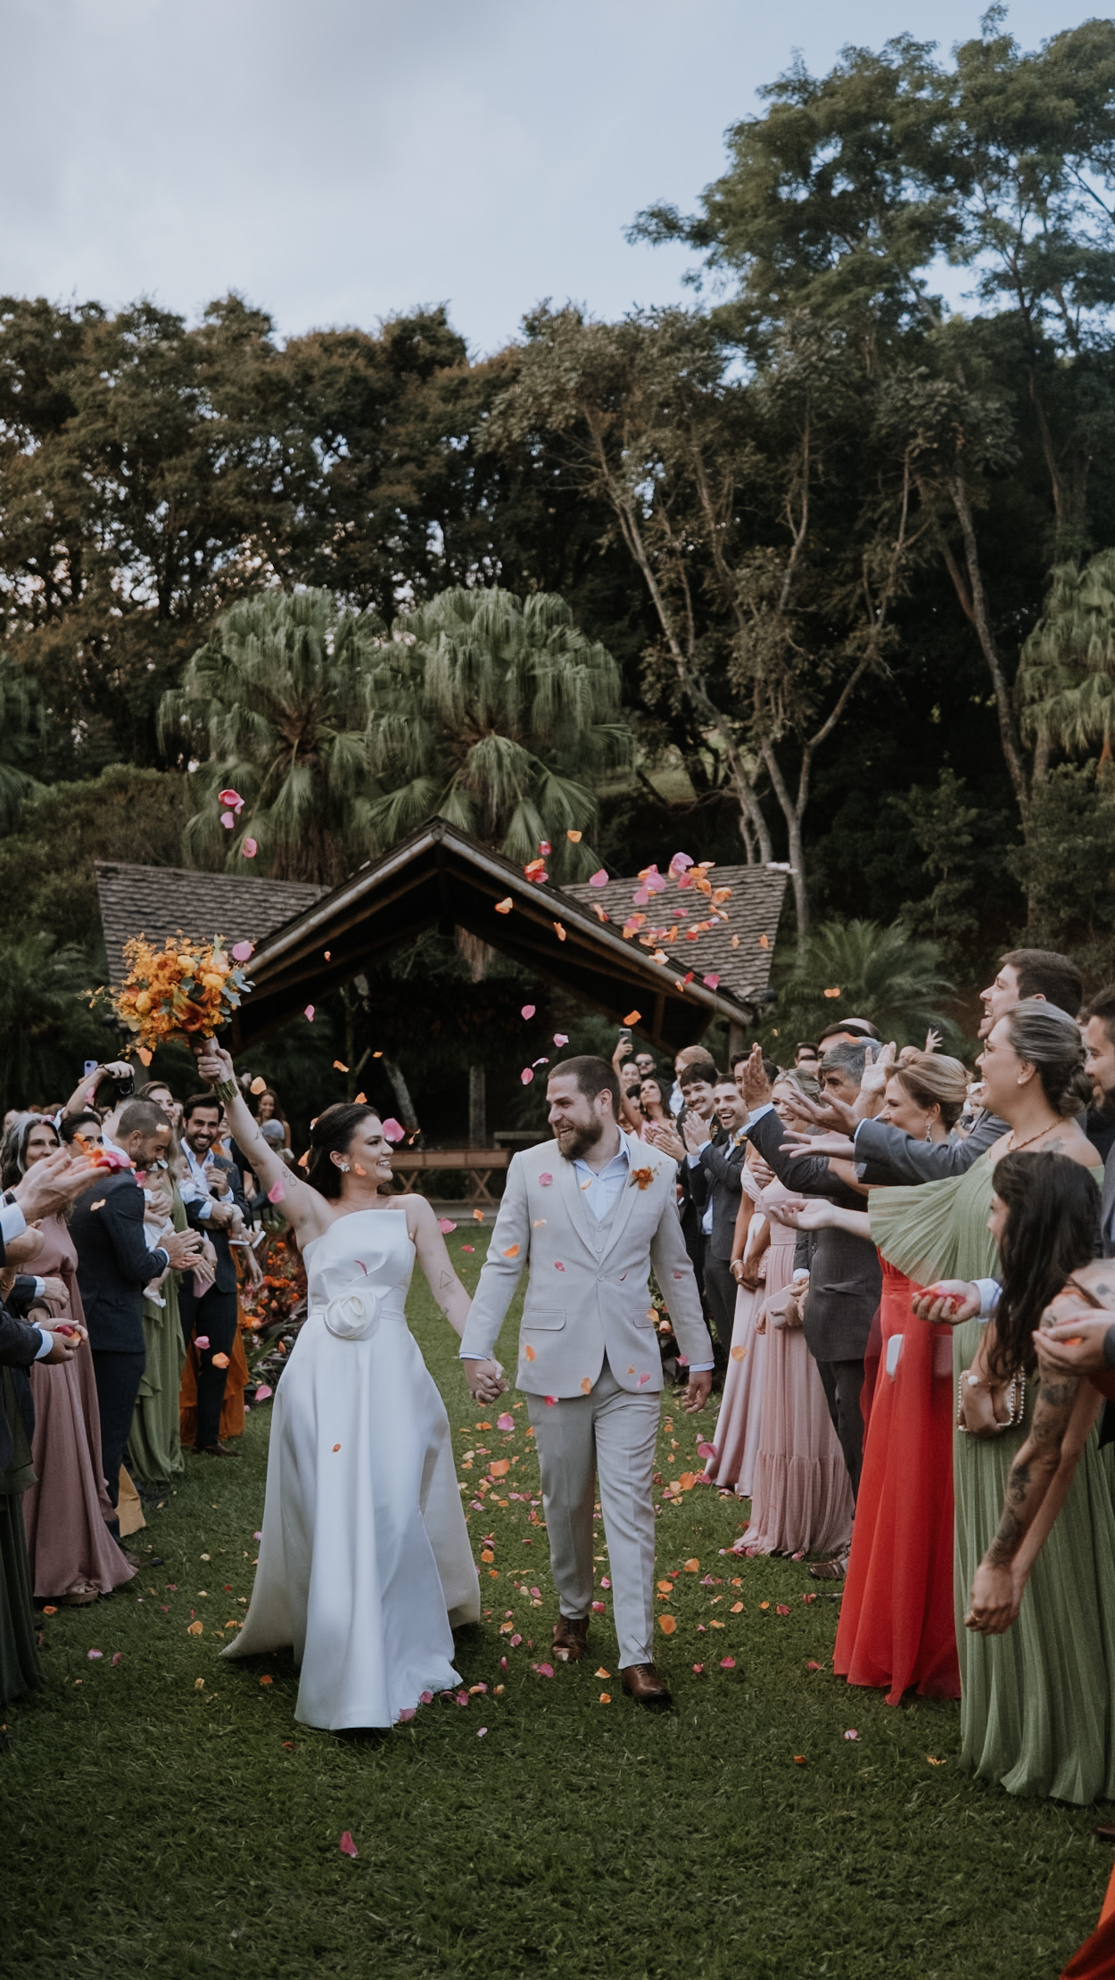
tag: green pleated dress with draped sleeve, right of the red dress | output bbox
[869,1154,1115,1804]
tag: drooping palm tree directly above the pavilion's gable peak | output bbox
[366,588,632,879]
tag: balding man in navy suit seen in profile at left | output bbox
[69,1101,200,1505]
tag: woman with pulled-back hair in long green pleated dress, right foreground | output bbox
[869,1000,1115,1802]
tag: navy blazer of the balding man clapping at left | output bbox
[69,1168,166,1354]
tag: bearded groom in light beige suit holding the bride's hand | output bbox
[461,1057,713,1705]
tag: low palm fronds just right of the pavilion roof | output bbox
[774,921,957,1047]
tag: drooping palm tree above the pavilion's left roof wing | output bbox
[158,590,376,885]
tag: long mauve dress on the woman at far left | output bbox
[24,1216,135,1602]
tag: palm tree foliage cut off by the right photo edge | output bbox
[1018,550,1115,760]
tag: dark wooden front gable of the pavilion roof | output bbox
[234,818,784,1049]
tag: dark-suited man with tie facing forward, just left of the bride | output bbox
[178,1093,248,1457]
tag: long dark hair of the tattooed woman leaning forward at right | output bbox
[988,1150,1099,1382]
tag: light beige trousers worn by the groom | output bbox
[527,1360,659,1669]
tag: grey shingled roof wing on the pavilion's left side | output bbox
[97,859,329,984]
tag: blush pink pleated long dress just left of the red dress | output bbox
[739,1182,852,1554]
